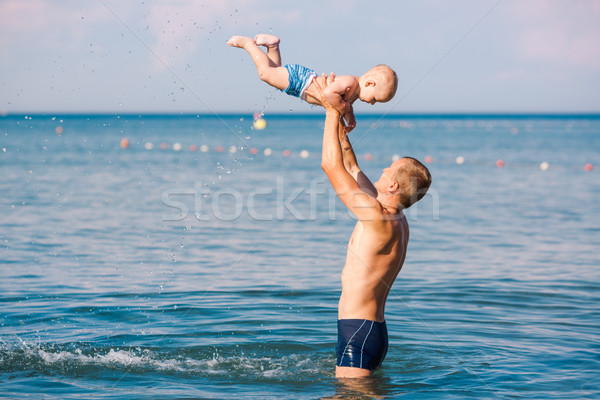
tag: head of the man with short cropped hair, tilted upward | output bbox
[375,157,431,210]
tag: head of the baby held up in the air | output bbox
[358,64,398,104]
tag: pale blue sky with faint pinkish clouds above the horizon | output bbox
[0,0,600,114]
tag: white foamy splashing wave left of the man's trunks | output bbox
[0,339,335,380]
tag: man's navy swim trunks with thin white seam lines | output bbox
[335,319,388,371]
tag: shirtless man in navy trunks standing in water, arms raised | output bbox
[315,76,431,378]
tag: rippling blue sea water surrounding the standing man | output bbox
[0,115,600,399]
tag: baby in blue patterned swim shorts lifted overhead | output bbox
[227,33,398,132]
